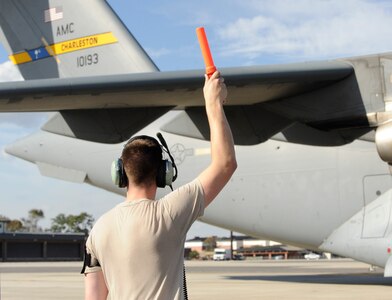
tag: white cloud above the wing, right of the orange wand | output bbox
[218,0,392,59]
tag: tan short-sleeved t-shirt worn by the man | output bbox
[85,179,204,300]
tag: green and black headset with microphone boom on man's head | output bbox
[111,132,178,190]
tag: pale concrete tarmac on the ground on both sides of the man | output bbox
[0,259,392,300]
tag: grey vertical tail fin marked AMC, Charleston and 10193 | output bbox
[0,0,158,80]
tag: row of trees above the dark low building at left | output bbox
[0,209,95,234]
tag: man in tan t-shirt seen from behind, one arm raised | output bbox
[84,71,237,300]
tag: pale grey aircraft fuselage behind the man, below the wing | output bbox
[7,112,391,266]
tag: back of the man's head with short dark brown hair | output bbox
[121,136,162,186]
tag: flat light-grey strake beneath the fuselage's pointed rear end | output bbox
[36,161,87,183]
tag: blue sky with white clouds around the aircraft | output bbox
[0,0,392,238]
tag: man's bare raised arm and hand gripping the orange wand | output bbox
[198,71,237,207]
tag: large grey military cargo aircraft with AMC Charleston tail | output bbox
[0,0,392,276]
